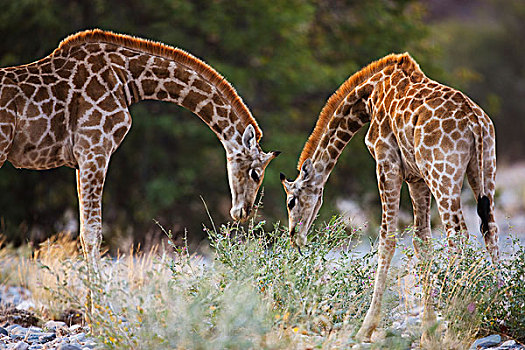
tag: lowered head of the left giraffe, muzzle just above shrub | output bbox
[227,125,281,222]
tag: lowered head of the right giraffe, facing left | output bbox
[281,158,323,248]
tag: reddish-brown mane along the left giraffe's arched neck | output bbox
[52,29,262,141]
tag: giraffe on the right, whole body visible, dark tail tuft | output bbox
[281,53,499,340]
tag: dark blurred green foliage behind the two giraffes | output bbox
[0,0,525,249]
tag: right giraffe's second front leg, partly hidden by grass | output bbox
[408,180,436,336]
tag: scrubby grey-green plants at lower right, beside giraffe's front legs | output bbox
[398,231,525,348]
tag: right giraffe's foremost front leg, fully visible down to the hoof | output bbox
[356,161,403,341]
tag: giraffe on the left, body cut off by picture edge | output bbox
[0,29,279,268]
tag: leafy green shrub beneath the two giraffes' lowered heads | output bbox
[207,213,376,334]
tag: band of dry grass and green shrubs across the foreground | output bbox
[0,219,525,349]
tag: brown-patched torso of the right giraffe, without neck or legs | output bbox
[366,55,495,186]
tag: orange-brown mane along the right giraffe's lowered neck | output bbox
[297,52,417,170]
